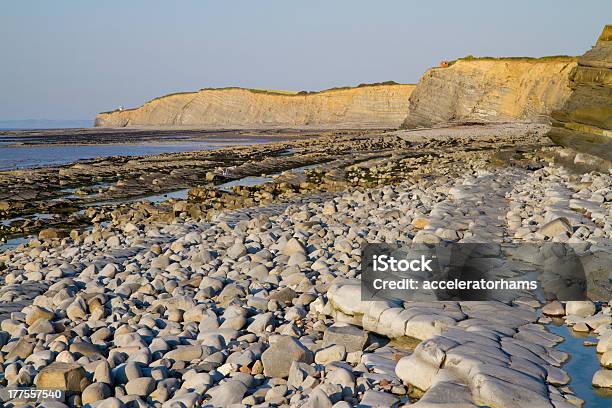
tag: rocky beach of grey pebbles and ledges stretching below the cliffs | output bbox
[0,118,612,407]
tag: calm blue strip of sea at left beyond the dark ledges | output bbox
[0,138,269,170]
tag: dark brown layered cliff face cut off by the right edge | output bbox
[548,25,612,167]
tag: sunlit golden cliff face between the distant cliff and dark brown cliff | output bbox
[402,57,576,128]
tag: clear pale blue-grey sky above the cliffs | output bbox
[0,0,612,120]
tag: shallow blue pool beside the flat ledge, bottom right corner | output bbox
[546,323,612,408]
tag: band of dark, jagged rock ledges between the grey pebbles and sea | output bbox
[0,124,539,250]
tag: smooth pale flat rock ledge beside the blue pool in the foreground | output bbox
[326,279,575,408]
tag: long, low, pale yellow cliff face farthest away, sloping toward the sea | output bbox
[95,84,414,128]
